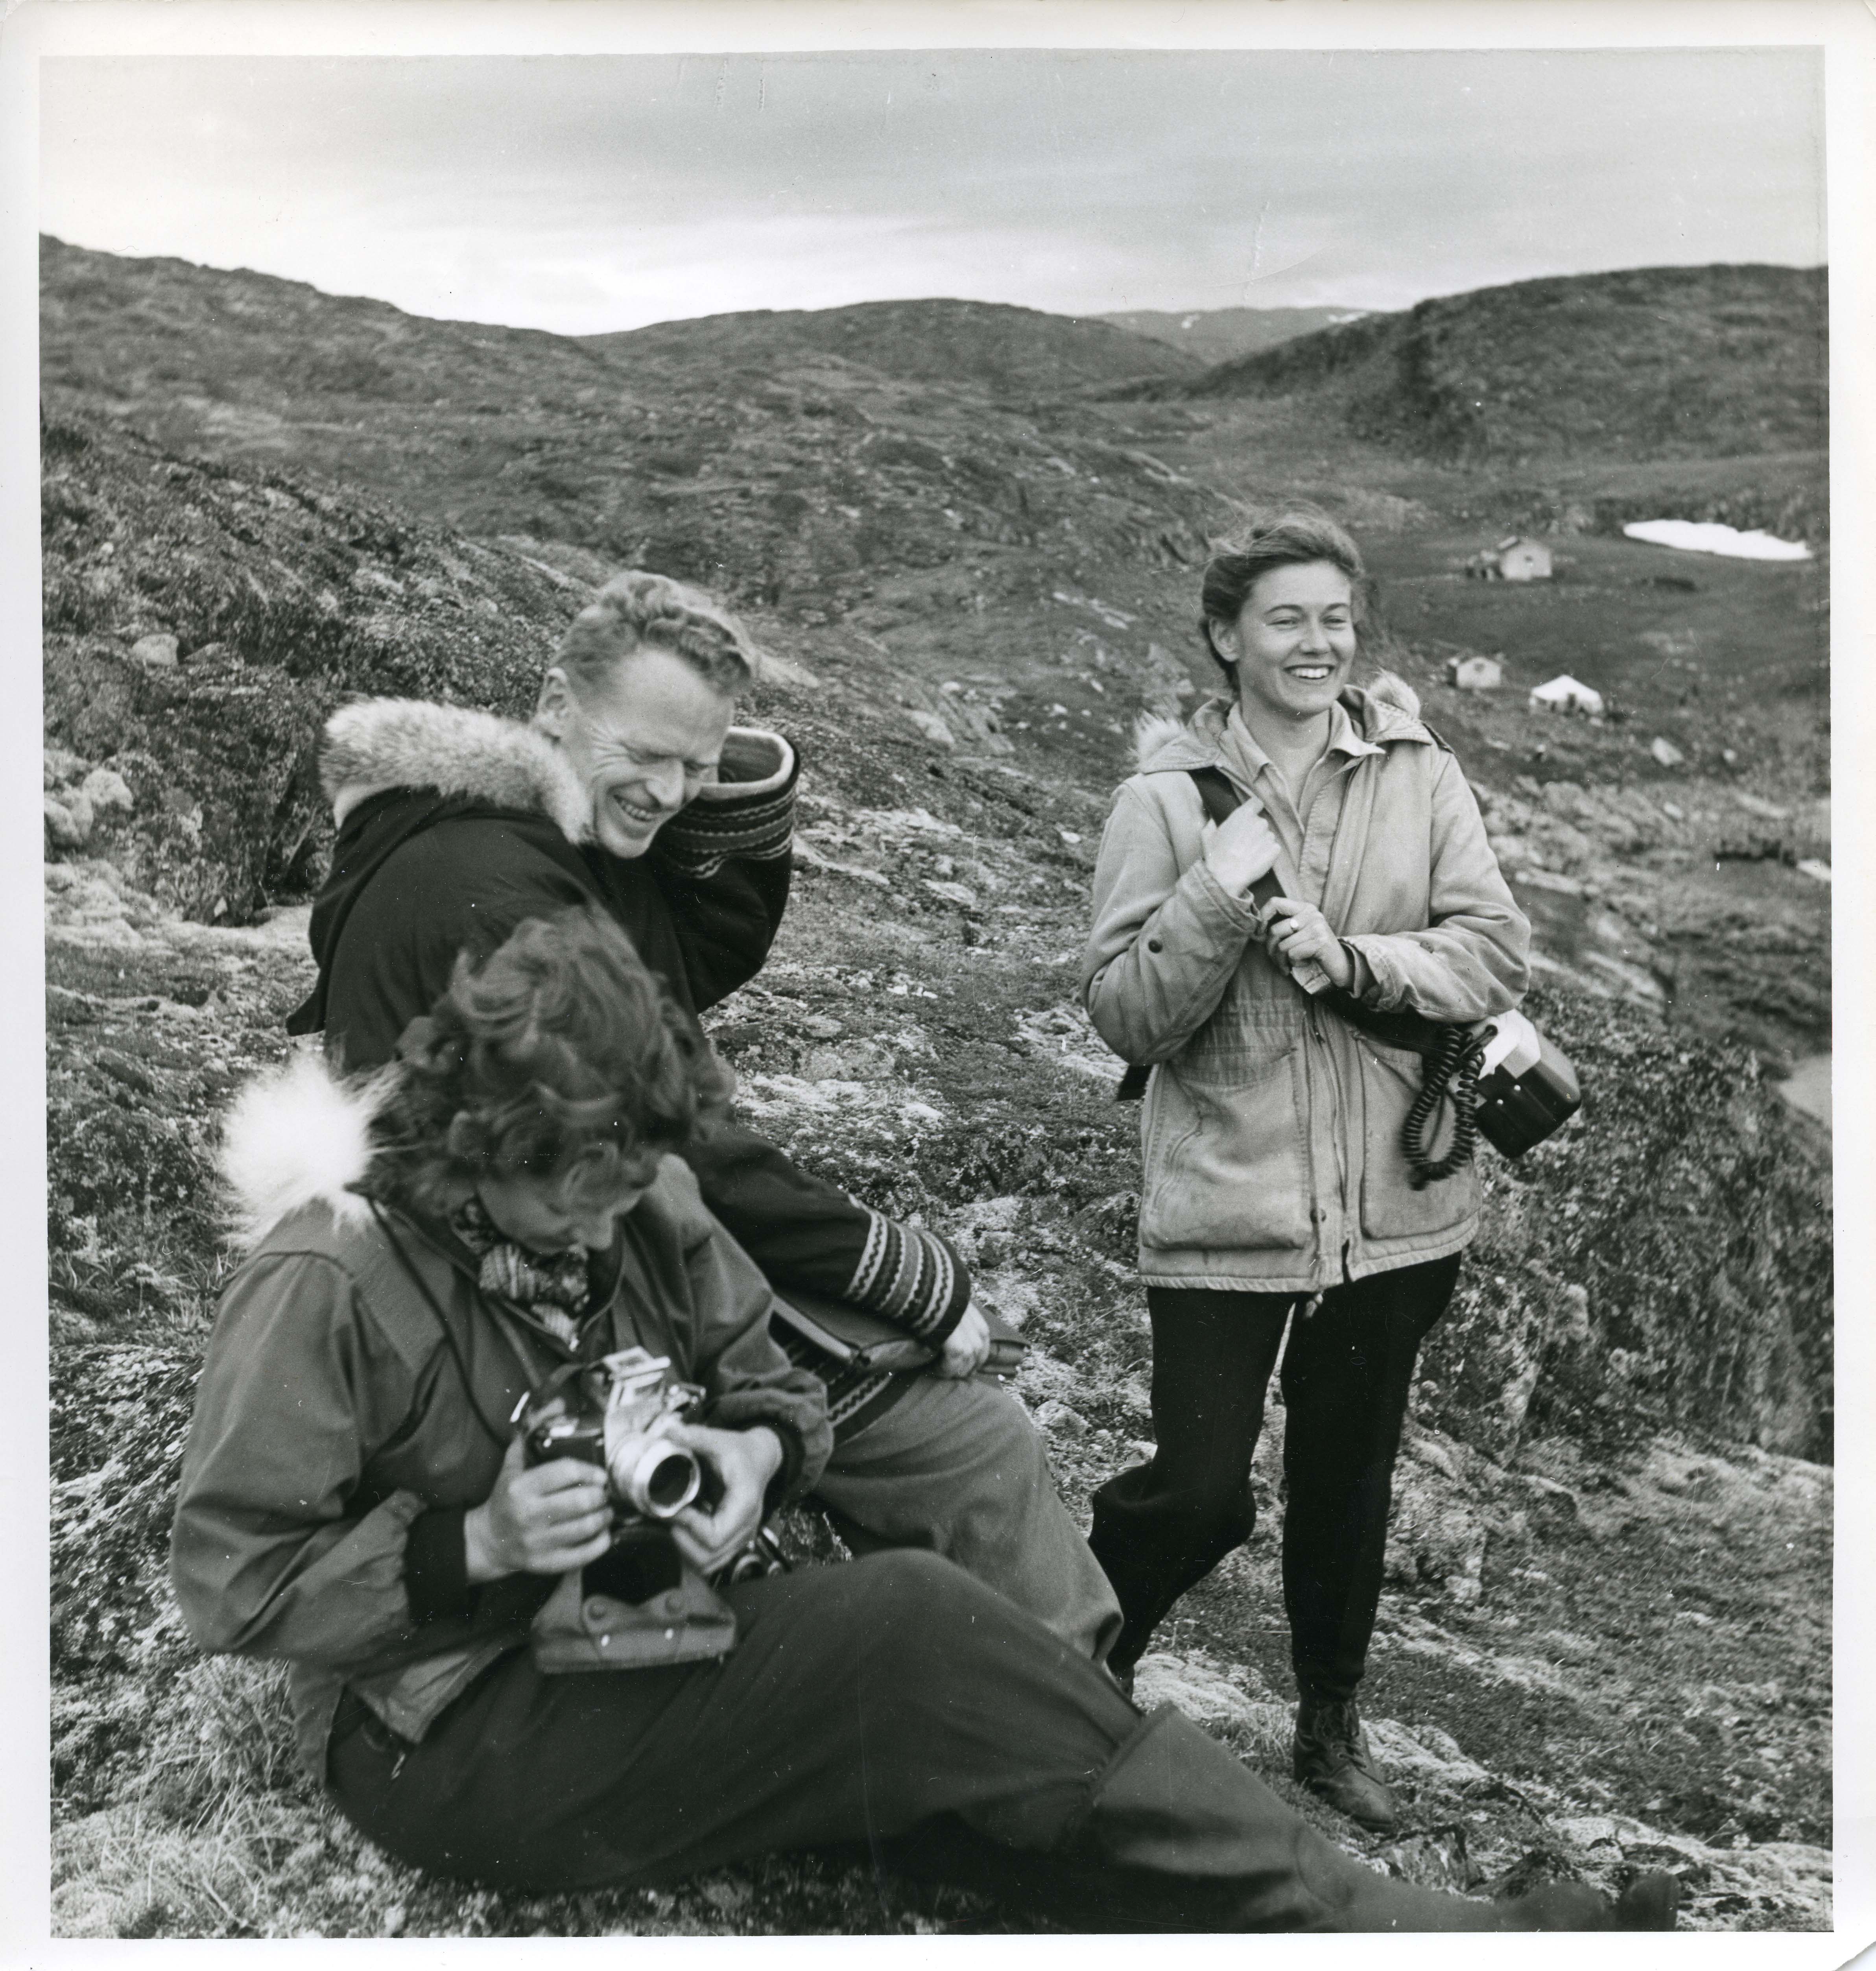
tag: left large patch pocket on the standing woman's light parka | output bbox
[1141,1021,1308,1251]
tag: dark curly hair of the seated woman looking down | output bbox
[374,907,731,1210]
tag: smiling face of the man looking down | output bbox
[536,644,735,859]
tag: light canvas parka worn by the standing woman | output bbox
[1082,674,1529,1293]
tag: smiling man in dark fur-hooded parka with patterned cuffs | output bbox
[288,572,1119,1661]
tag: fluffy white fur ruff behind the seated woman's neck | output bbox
[217,1052,394,1248]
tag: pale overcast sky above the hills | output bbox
[39,49,1825,333]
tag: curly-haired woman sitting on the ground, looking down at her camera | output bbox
[172,911,1675,1930]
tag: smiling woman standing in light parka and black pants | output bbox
[1082,511,1529,1831]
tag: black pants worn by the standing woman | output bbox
[1090,1253,1458,1699]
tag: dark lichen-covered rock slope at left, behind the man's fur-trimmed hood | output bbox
[43,418,587,923]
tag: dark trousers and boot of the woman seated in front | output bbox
[327,1553,1502,1930]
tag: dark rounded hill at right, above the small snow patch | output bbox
[1129,266,1829,459]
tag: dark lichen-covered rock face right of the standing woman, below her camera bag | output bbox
[1419,989,1835,1460]
